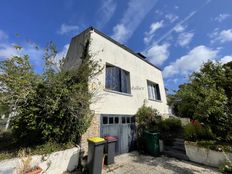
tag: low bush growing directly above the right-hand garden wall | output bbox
[184,121,215,141]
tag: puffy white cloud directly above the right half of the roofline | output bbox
[144,43,170,65]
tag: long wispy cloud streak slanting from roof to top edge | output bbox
[112,0,157,42]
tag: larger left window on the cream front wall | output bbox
[105,64,131,93]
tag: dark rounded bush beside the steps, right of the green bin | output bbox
[159,118,182,145]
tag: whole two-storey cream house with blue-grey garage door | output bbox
[64,27,168,153]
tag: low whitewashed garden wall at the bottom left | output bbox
[0,147,80,174]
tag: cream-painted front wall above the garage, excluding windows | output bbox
[90,31,168,115]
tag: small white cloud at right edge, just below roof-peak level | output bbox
[210,28,232,43]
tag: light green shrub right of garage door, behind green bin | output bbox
[135,104,161,152]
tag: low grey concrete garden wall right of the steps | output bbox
[185,142,232,167]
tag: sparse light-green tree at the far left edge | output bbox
[0,55,39,129]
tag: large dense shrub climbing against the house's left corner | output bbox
[6,42,101,146]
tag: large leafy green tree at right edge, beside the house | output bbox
[169,62,232,142]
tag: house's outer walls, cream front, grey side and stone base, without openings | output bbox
[63,30,168,152]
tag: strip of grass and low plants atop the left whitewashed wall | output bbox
[0,131,75,160]
